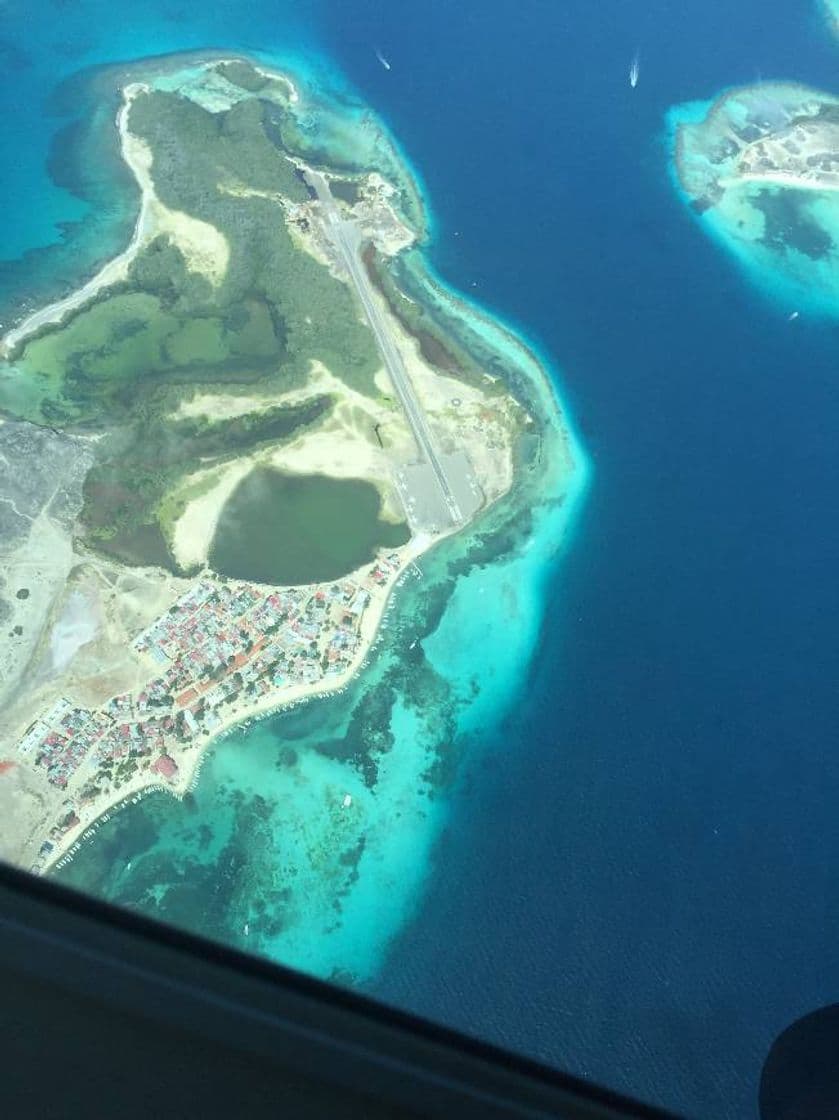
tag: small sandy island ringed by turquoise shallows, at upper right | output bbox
[670,82,839,317]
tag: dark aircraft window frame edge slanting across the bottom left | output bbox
[0,865,666,1120]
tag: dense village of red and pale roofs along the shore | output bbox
[17,553,400,869]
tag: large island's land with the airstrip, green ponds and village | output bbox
[0,57,524,874]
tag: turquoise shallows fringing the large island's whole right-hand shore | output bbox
[55,62,588,982]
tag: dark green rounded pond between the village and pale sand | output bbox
[209,467,409,585]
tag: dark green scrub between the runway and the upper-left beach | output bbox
[130,92,379,395]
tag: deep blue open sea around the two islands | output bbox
[0,0,839,1118]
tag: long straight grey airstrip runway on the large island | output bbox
[306,171,464,525]
